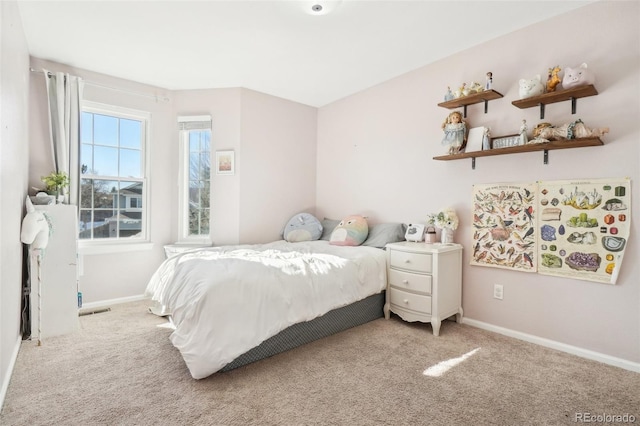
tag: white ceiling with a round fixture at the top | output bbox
[18,0,592,107]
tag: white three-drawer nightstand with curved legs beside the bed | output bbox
[384,241,462,336]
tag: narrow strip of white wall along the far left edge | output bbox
[0,1,29,407]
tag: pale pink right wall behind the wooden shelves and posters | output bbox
[317,2,640,363]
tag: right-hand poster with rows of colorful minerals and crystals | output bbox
[538,178,631,284]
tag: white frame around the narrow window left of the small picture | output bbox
[177,115,213,245]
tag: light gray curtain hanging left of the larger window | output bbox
[43,69,84,205]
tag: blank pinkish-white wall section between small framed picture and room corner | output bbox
[238,89,317,243]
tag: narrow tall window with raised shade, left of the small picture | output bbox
[178,116,211,243]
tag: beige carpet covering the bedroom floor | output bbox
[0,302,640,425]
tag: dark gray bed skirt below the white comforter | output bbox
[220,291,385,371]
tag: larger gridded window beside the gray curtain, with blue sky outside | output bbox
[78,102,149,242]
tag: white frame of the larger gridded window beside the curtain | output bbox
[77,101,153,254]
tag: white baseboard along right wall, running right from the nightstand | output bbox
[462,317,640,373]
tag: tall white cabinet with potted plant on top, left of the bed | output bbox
[29,204,79,339]
